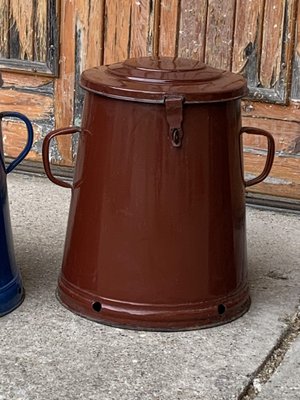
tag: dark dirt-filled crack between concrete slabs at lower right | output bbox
[237,306,300,400]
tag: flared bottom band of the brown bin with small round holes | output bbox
[57,277,251,331]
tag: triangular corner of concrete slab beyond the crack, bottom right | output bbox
[257,337,300,400]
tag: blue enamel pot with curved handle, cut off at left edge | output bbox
[0,111,33,316]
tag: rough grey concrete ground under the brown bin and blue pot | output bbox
[0,174,300,400]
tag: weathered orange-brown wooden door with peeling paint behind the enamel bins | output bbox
[0,0,300,201]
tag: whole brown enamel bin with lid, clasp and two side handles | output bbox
[43,57,274,330]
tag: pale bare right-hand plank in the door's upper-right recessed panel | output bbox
[260,0,286,88]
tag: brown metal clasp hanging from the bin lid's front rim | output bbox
[165,96,184,147]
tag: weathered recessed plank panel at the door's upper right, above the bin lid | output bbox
[232,0,297,104]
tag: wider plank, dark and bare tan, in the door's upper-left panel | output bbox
[9,0,34,60]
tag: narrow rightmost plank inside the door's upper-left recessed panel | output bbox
[33,0,49,62]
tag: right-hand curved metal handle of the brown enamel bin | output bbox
[240,126,275,187]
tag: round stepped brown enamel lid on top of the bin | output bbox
[80,57,248,103]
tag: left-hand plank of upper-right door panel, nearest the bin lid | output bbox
[232,0,264,87]
